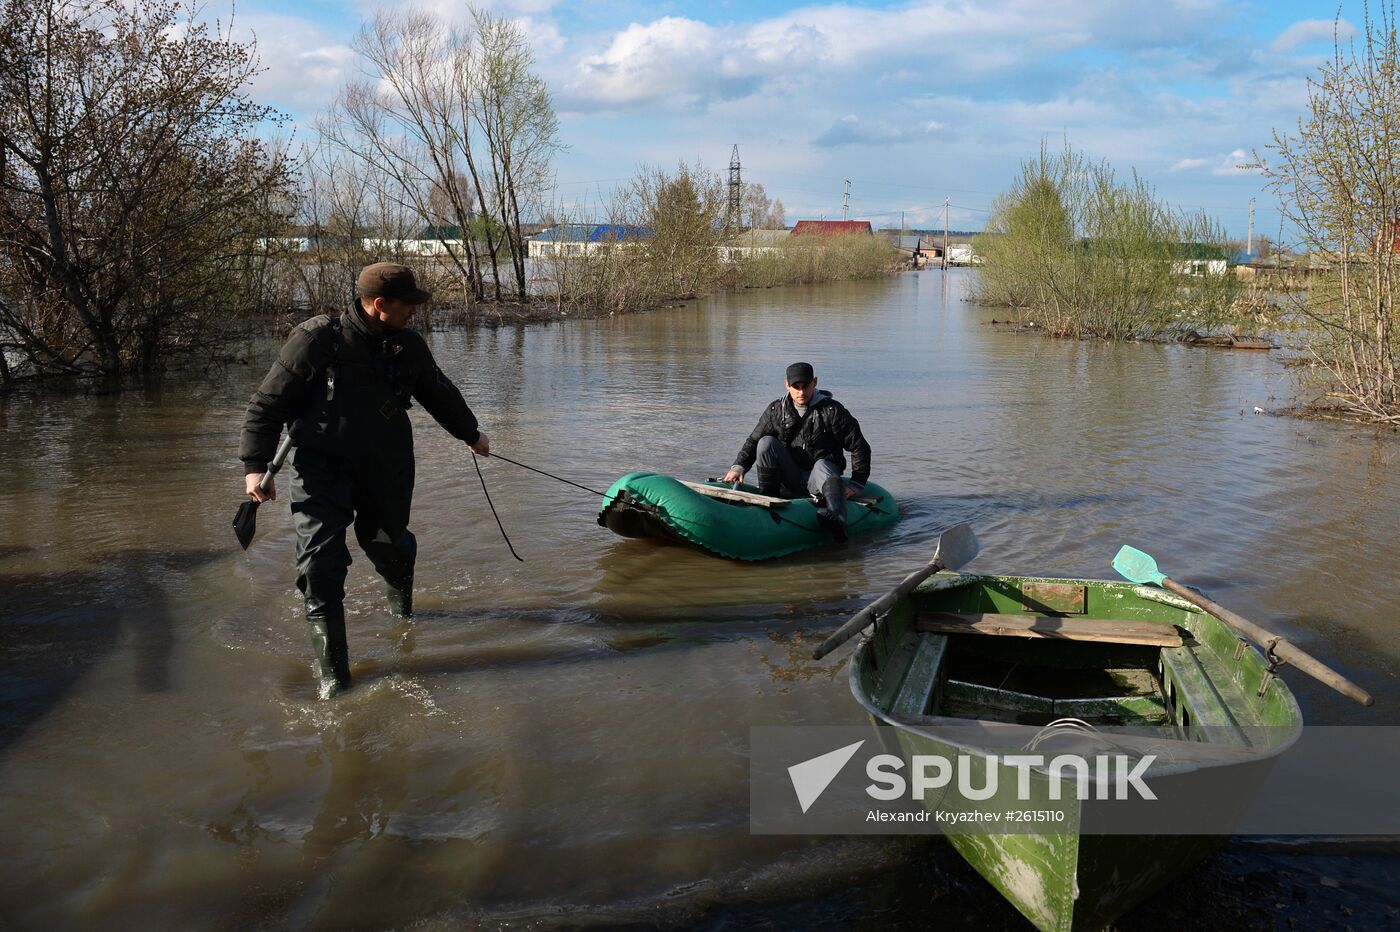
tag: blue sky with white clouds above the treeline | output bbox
[226,0,1362,236]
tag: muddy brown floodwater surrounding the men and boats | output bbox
[0,271,1400,929]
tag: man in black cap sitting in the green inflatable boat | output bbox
[724,362,871,540]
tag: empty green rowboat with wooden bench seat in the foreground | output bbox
[850,572,1302,931]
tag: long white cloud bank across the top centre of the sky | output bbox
[566,0,1224,109]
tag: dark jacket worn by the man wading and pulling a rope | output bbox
[238,301,480,473]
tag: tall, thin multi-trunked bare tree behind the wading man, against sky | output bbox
[321,4,559,307]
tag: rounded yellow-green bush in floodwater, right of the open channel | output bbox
[973,144,1238,340]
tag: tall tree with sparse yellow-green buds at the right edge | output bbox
[1256,3,1400,423]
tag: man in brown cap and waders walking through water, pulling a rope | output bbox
[238,262,491,698]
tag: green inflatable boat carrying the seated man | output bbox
[598,473,899,560]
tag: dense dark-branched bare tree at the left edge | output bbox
[0,0,290,375]
